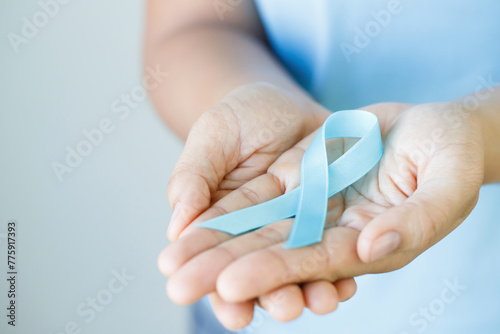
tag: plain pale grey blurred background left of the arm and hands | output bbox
[0,0,188,334]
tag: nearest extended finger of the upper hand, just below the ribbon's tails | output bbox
[217,227,390,301]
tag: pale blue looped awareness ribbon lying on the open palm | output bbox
[197,110,383,248]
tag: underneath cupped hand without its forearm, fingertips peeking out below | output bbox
[160,83,356,328]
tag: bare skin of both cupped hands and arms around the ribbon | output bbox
[145,0,500,329]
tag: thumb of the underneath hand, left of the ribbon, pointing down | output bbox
[167,111,239,241]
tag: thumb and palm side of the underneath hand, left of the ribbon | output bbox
[168,83,330,241]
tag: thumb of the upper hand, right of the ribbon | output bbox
[357,177,477,264]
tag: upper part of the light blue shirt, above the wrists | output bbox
[257,0,500,111]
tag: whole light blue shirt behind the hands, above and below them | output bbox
[193,0,500,334]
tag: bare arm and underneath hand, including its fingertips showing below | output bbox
[144,0,356,328]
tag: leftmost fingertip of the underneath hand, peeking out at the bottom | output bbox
[209,292,254,330]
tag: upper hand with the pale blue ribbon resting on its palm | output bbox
[159,103,484,326]
